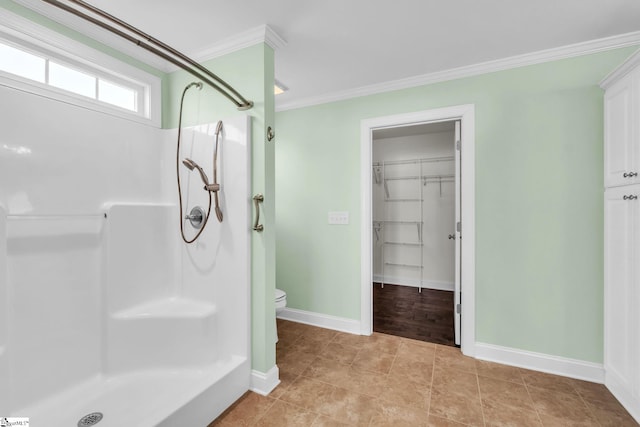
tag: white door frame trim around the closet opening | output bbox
[361,105,475,356]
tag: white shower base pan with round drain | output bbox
[15,357,250,427]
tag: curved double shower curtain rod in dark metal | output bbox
[43,0,253,110]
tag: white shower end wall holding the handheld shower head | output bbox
[179,119,253,359]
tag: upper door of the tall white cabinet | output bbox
[604,73,640,187]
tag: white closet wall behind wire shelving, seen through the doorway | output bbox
[372,131,455,290]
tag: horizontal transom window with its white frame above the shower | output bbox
[0,7,164,127]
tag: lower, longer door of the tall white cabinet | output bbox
[604,185,640,401]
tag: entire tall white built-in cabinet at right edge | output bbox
[601,48,640,421]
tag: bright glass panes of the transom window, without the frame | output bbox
[0,40,144,113]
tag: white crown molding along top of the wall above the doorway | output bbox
[276,31,640,111]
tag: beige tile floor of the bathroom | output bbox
[211,320,638,427]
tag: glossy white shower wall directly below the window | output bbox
[0,86,169,414]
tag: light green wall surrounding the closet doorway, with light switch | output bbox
[276,48,635,362]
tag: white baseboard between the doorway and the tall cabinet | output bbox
[475,342,604,384]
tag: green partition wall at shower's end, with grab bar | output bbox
[162,43,276,372]
